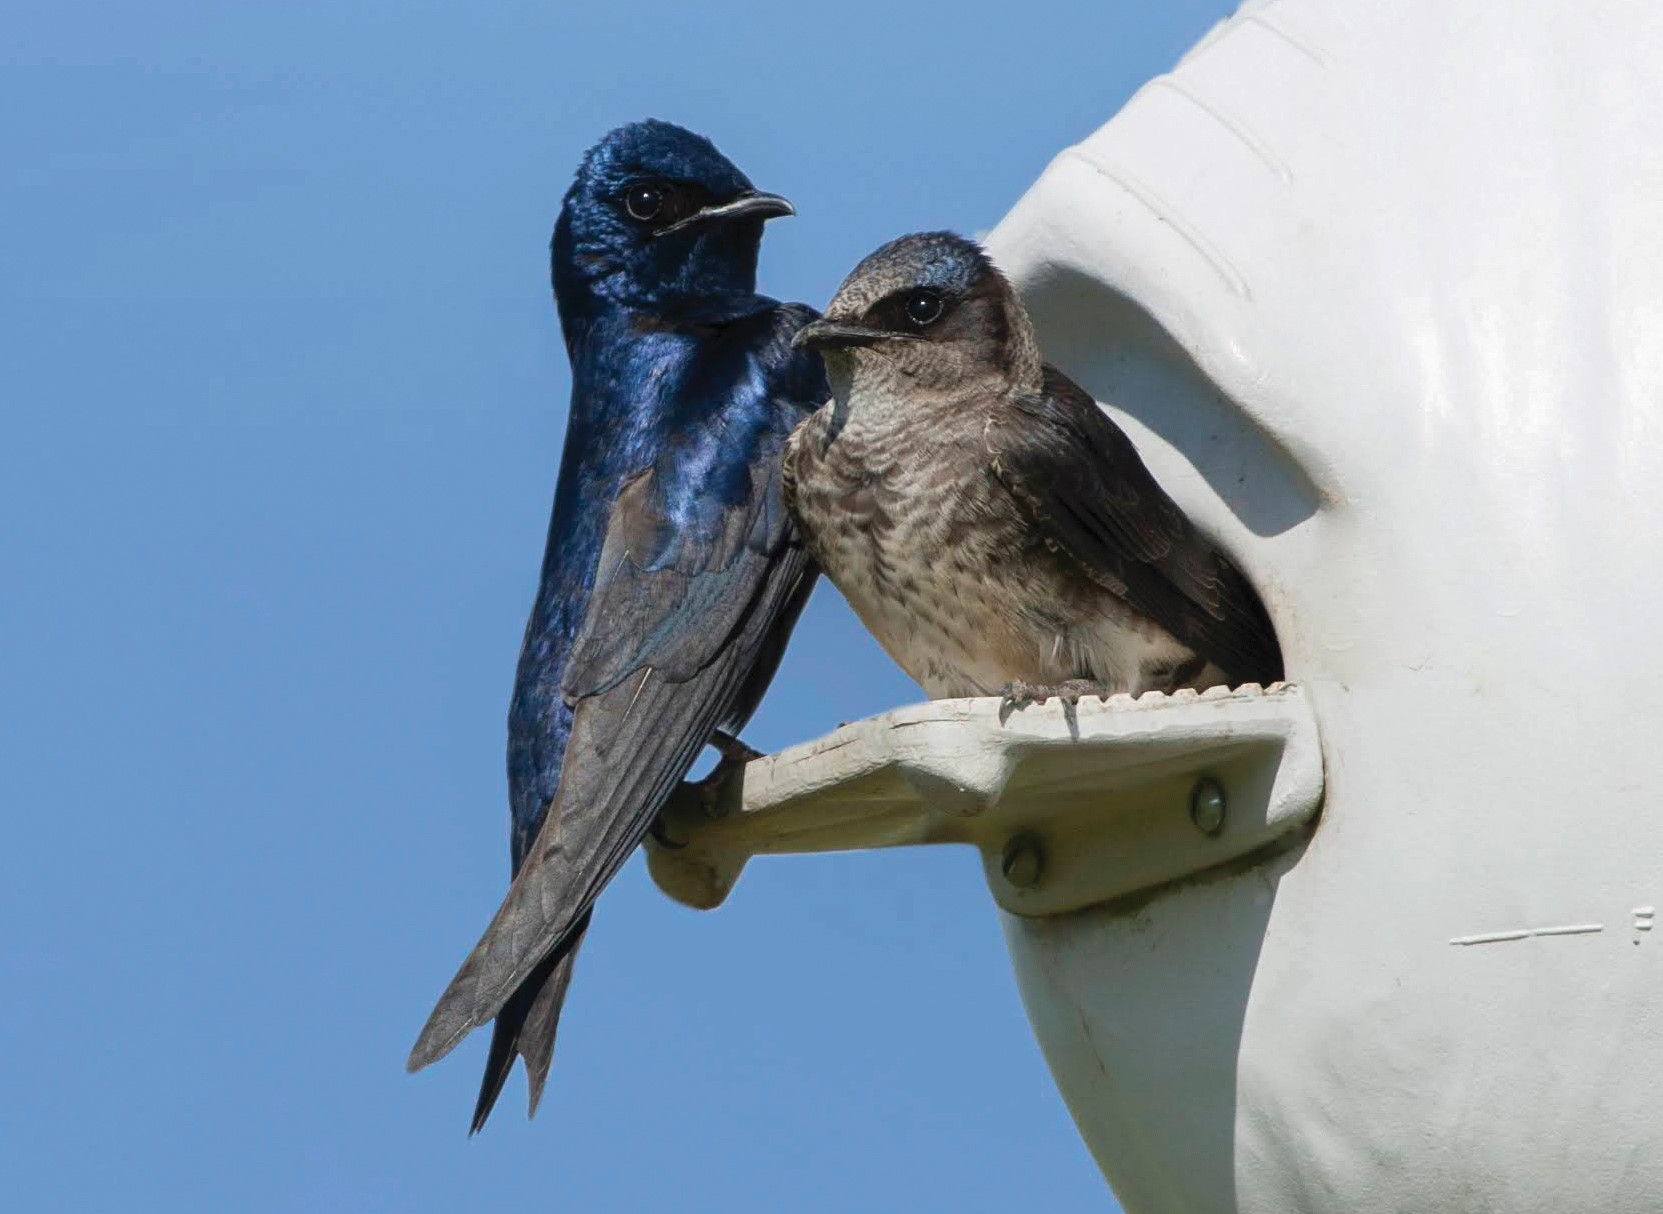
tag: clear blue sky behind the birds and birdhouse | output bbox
[0,0,1229,1214]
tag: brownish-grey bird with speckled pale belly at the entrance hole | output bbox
[785,233,1282,705]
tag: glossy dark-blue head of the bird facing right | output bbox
[550,118,793,313]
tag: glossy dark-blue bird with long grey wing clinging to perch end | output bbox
[409,121,827,1131]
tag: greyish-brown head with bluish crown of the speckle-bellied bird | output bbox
[797,231,1043,396]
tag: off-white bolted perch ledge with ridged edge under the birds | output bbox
[647,683,1322,916]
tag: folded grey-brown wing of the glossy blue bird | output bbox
[409,431,815,1069]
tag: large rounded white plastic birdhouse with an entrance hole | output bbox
[989,0,1663,1214]
